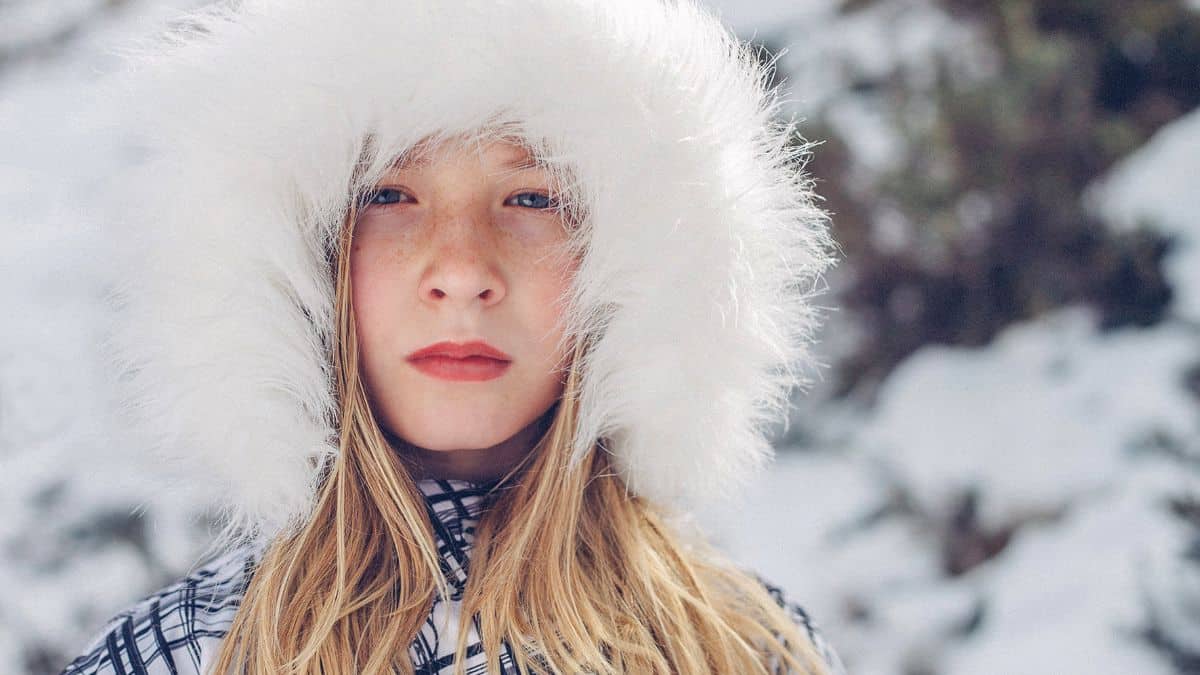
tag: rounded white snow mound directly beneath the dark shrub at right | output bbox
[858,302,1196,525]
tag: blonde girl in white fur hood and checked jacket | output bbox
[66,0,844,675]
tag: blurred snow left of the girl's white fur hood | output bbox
[0,2,218,673]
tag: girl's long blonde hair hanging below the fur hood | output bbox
[214,171,827,675]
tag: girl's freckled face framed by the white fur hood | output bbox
[350,141,575,479]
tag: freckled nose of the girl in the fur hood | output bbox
[418,211,505,309]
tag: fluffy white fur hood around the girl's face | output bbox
[100,0,836,534]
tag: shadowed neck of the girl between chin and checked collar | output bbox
[384,406,557,483]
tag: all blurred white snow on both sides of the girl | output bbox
[0,1,1200,675]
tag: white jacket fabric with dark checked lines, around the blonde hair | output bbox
[62,479,846,675]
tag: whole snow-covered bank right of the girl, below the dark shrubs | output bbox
[707,307,1200,675]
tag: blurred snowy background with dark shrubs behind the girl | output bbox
[0,0,1200,675]
